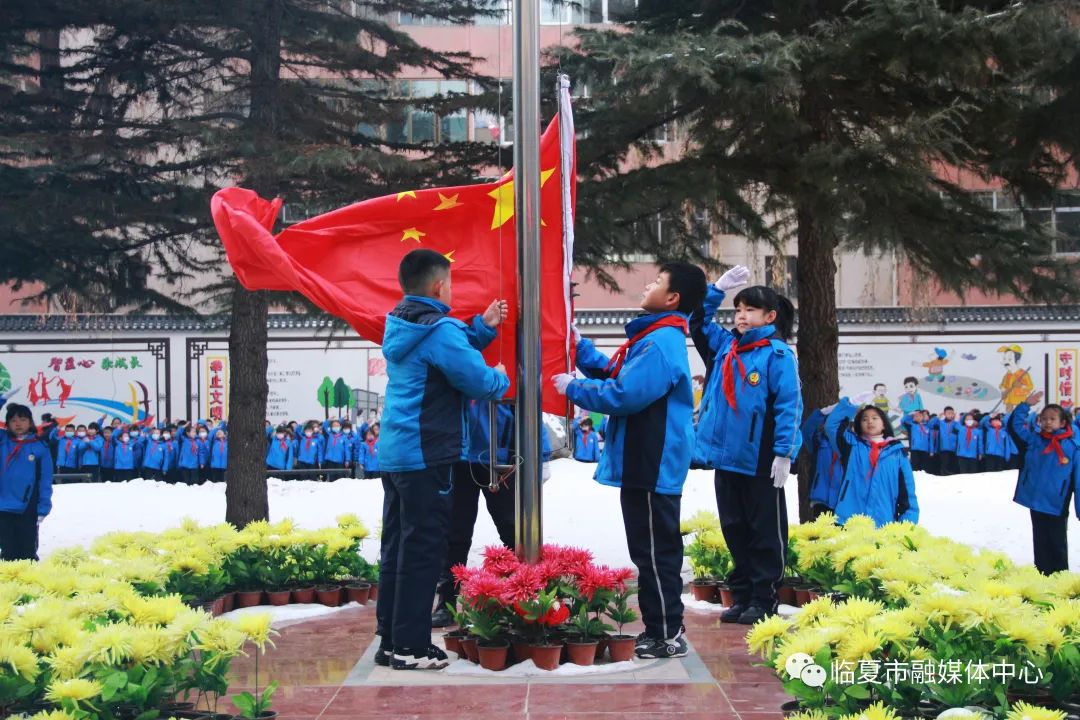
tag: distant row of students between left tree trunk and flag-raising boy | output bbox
[266,418,380,478]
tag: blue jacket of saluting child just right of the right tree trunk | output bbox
[825,397,919,527]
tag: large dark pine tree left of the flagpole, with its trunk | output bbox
[0,0,489,527]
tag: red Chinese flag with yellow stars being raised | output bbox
[211,118,577,416]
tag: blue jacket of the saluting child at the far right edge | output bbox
[1009,403,1080,517]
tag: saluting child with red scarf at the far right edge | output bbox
[1009,392,1080,575]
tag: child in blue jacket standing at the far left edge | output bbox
[0,398,53,560]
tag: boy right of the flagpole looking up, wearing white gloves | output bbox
[553,262,705,657]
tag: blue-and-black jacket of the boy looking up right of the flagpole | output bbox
[566,312,693,495]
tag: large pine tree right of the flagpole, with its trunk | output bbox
[557,0,1080,516]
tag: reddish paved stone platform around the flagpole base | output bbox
[225,604,791,720]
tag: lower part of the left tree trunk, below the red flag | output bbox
[225,282,270,528]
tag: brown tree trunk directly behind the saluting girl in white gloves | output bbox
[796,206,840,522]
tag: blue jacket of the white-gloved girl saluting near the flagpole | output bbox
[693,285,802,477]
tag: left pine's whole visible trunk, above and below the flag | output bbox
[225,0,284,528]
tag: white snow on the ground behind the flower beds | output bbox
[35,459,1080,570]
